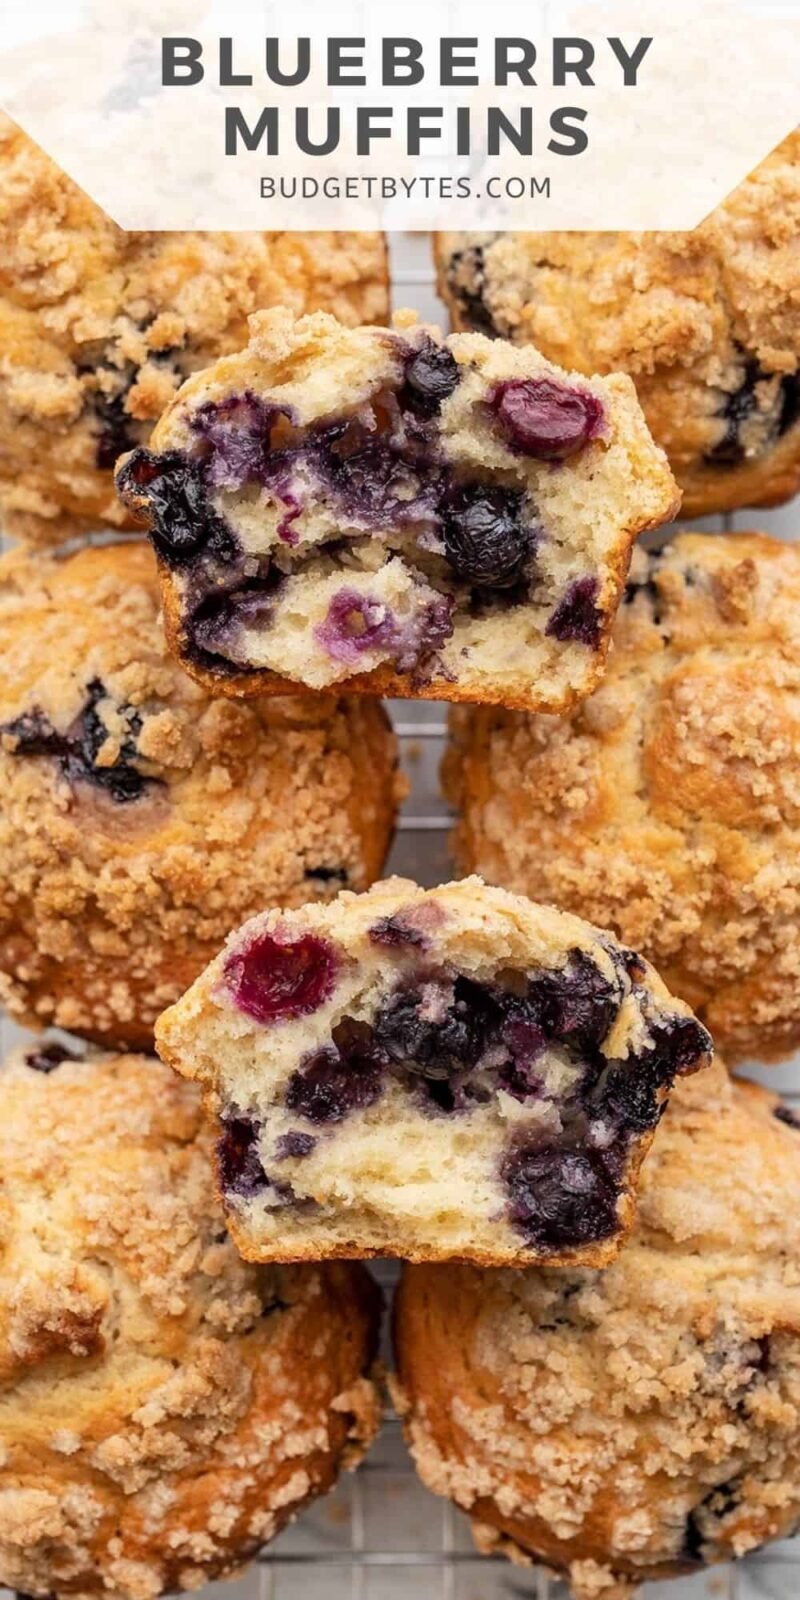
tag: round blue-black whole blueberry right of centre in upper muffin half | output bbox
[442,485,538,589]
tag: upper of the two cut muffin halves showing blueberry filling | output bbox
[117,310,677,710]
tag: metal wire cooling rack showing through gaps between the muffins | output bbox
[0,235,800,1600]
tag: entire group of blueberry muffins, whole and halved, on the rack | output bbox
[0,123,800,1600]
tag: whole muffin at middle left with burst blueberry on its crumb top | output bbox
[0,542,397,1048]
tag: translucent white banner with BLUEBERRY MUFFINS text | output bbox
[0,0,800,230]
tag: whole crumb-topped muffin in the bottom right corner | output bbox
[395,1067,800,1600]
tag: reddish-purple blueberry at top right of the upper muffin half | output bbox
[488,378,606,461]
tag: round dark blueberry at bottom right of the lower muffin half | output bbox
[502,1144,619,1254]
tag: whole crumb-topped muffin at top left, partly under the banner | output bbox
[0,118,389,546]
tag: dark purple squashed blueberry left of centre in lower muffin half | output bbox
[286,1018,386,1123]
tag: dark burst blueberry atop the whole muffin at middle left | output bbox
[0,678,162,805]
